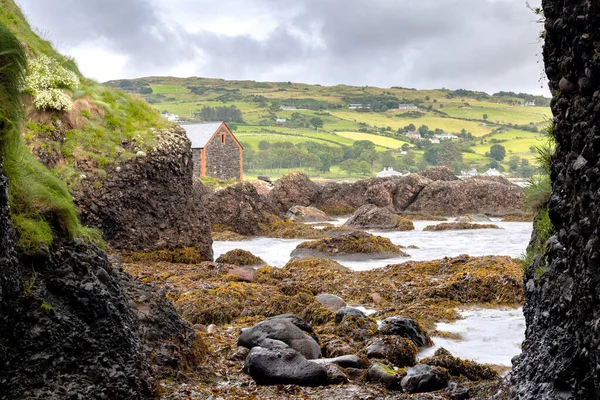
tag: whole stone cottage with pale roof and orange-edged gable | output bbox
[183,122,243,180]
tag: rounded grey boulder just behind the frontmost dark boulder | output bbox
[238,318,321,359]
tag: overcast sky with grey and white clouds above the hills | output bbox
[17,0,548,94]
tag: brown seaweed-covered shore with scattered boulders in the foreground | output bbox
[123,256,523,399]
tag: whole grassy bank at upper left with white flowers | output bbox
[0,0,167,253]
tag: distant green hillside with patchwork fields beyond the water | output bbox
[106,77,551,178]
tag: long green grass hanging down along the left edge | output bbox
[0,21,102,254]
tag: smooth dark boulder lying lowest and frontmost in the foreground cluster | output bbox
[243,347,329,386]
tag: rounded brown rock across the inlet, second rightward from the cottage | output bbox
[269,172,321,213]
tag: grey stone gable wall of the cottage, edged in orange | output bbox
[206,128,242,180]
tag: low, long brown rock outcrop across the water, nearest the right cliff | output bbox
[406,177,523,216]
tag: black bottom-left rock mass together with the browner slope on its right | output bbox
[0,166,205,400]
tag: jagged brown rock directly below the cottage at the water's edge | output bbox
[202,182,287,235]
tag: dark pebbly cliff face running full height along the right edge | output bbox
[512,0,600,399]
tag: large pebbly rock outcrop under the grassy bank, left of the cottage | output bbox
[74,127,212,260]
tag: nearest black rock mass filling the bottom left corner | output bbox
[0,241,153,399]
